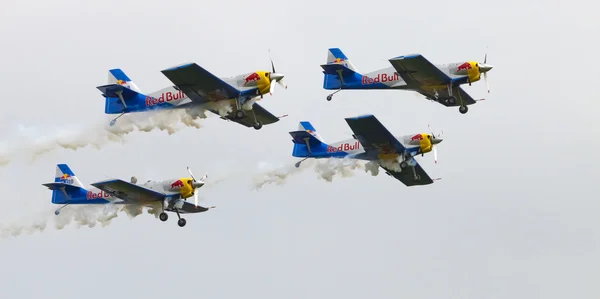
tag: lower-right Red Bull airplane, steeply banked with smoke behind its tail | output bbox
[289,114,443,187]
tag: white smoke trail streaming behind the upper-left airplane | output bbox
[0,106,211,166]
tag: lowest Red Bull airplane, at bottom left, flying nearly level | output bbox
[42,164,214,227]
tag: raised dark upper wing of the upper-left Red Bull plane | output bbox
[161,63,240,103]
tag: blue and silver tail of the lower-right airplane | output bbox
[289,121,327,158]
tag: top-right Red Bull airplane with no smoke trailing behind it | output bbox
[321,48,493,114]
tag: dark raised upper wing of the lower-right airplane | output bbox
[346,115,406,154]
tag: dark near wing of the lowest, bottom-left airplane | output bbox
[91,179,166,202]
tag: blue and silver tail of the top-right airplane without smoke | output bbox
[321,48,360,89]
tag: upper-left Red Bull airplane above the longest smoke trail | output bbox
[96,55,287,130]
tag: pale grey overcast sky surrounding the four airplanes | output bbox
[0,0,600,299]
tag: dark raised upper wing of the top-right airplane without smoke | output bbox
[389,54,452,86]
